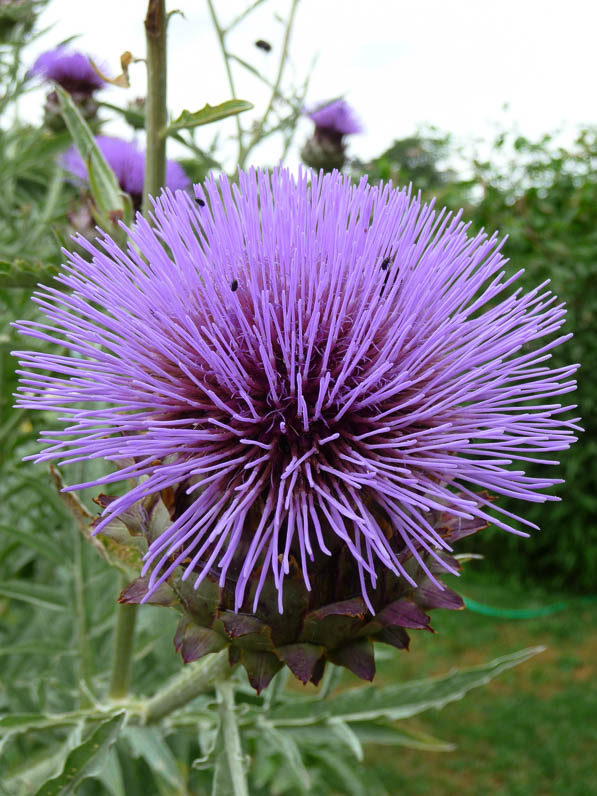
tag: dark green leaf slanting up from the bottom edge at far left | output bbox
[35,711,125,796]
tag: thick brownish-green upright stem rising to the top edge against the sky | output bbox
[143,0,168,216]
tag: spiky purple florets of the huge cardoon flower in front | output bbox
[18,170,577,620]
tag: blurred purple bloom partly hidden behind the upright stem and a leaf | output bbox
[62,135,190,209]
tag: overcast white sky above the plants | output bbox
[21,0,597,165]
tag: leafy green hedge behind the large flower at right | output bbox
[356,130,597,591]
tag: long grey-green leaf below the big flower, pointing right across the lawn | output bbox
[269,647,545,726]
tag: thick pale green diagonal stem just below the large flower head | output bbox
[145,650,232,724]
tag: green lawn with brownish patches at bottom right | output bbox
[366,564,597,796]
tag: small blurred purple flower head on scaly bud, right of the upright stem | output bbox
[301,99,363,171]
